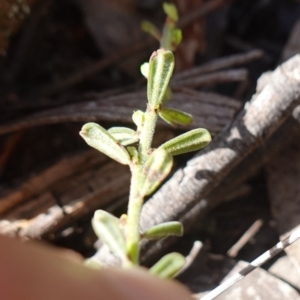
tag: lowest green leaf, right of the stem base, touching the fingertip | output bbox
[149,252,185,278]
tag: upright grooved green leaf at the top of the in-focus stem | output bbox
[147,49,175,109]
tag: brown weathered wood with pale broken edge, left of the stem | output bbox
[0,130,174,239]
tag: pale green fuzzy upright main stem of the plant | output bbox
[126,106,157,265]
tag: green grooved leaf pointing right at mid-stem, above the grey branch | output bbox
[159,128,211,156]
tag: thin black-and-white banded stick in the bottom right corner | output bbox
[200,229,300,300]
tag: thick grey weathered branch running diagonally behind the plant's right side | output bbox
[91,55,300,264]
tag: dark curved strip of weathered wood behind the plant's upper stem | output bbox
[0,90,241,134]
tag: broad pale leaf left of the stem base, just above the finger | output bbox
[92,210,127,261]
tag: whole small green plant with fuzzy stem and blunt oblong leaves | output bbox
[80,3,211,278]
